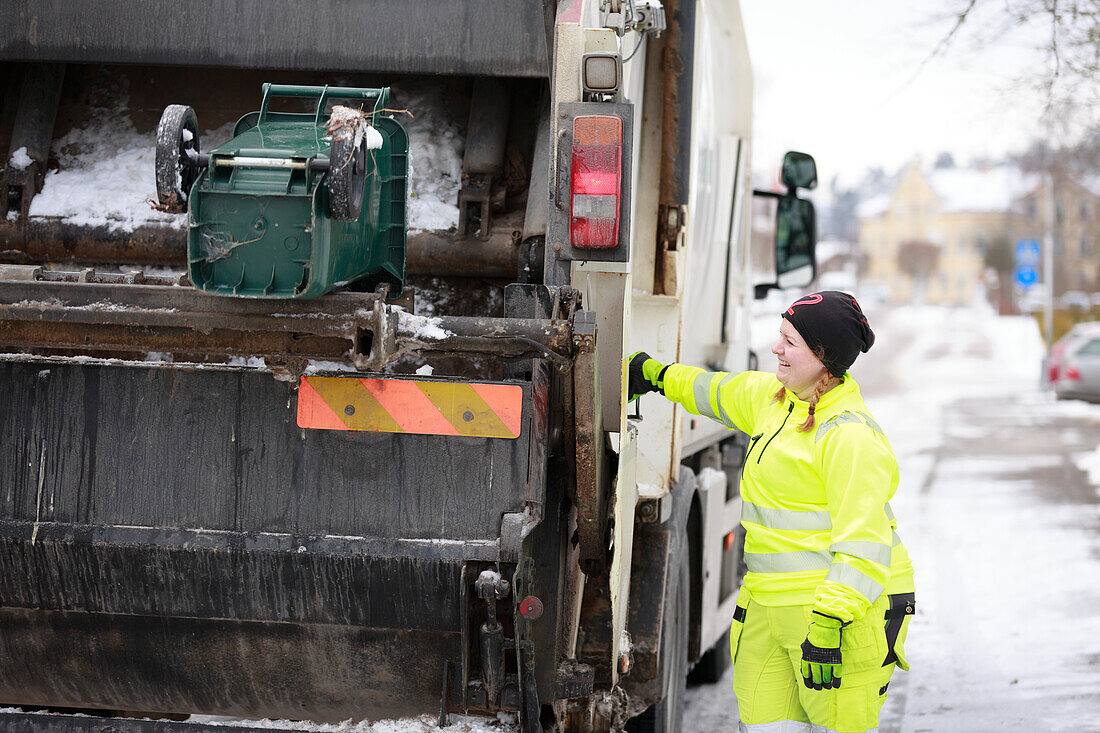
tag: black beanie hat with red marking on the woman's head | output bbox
[783,291,875,376]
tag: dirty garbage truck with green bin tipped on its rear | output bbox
[0,0,815,732]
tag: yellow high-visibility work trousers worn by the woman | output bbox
[729,588,910,733]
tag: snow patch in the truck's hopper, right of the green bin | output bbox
[393,86,465,231]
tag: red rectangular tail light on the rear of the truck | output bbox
[569,114,623,249]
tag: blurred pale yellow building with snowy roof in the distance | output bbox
[858,164,1037,305]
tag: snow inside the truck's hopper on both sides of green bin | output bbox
[20,76,465,232]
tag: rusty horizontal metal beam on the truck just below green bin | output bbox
[0,280,573,371]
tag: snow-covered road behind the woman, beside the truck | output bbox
[684,301,1100,733]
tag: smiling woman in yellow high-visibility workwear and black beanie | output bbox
[629,291,914,733]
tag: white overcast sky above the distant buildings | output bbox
[741,0,1073,186]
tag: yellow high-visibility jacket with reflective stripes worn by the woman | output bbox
[663,364,913,621]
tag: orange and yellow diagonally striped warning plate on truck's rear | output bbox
[298,376,524,438]
